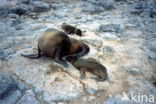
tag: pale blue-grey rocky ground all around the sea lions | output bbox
[0,0,156,104]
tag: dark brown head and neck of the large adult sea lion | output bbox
[66,38,90,57]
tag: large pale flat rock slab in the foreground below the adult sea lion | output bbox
[10,57,83,102]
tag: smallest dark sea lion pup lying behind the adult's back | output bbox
[61,23,82,36]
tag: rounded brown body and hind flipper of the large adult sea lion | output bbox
[21,28,71,61]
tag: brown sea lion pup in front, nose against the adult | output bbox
[63,56,108,81]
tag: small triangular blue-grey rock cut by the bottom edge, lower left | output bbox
[17,90,40,104]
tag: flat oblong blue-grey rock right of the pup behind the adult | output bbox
[99,24,122,33]
